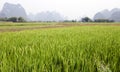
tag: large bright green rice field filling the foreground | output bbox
[0,26,120,72]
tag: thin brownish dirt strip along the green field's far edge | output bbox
[0,23,120,32]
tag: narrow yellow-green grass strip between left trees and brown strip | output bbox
[0,22,58,31]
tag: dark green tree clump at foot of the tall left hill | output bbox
[0,17,25,22]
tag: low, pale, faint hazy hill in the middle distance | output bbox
[28,11,65,21]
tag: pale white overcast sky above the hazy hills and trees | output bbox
[0,0,120,19]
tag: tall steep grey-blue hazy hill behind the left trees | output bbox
[0,3,27,19]
